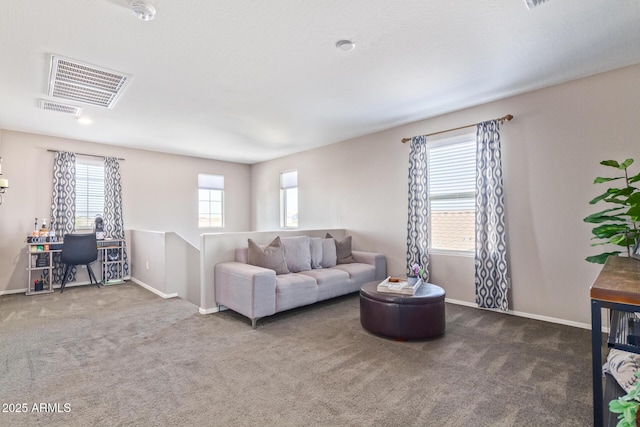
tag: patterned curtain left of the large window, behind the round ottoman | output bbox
[407,136,429,282]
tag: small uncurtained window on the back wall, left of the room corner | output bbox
[198,173,224,227]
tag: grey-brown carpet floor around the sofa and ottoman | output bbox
[0,283,592,427]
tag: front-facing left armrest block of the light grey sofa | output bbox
[214,262,276,320]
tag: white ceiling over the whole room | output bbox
[0,0,640,163]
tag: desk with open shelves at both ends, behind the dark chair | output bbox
[26,239,125,295]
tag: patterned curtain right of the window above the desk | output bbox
[102,157,129,281]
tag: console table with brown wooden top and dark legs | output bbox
[590,256,640,427]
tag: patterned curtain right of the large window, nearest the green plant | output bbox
[475,120,509,311]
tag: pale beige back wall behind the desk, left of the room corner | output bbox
[0,129,251,294]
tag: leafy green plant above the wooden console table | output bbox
[584,159,640,264]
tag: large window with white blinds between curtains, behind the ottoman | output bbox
[427,134,476,252]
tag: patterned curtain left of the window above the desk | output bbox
[51,151,76,283]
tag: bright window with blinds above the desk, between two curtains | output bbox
[75,157,104,230]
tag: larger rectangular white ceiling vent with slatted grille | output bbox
[48,55,132,108]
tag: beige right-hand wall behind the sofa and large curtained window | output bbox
[251,62,640,324]
